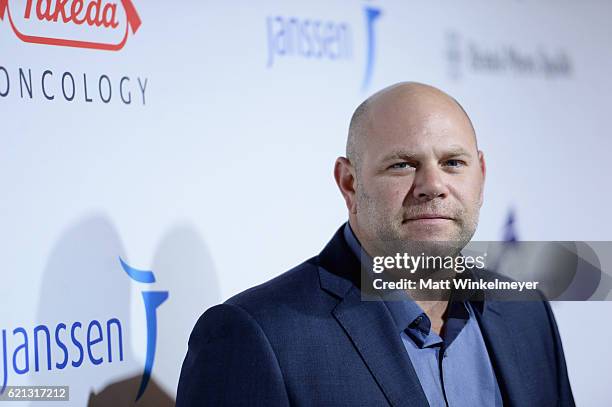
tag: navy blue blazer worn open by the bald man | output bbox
[177,228,574,407]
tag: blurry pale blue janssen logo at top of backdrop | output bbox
[266,6,382,90]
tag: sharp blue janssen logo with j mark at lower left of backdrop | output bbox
[0,258,168,400]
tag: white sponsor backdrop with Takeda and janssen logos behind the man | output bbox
[0,0,612,406]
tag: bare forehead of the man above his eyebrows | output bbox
[363,93,476,159]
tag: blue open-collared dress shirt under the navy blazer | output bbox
[344,222,503,407]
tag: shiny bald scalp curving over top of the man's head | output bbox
[346,82,478,173]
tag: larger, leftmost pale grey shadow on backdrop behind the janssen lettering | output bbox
[31,214,140,407]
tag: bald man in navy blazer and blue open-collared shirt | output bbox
[177,83,574,407]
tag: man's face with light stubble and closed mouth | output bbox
[352,94,484,255]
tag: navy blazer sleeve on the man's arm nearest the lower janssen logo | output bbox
[176,304,289,407]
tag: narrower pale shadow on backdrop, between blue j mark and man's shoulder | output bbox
[88,225,220,407]
